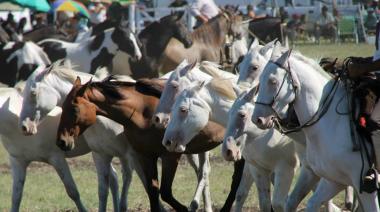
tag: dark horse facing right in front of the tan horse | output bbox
[130,13,192,79]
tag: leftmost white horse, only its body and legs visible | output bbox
[0,88,90,212]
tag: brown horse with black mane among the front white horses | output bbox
[57,78,239,211]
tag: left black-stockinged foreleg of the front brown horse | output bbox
[136,153,161,212]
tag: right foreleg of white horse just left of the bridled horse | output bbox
[272,164,296,212]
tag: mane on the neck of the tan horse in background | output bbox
[191,14,224,46]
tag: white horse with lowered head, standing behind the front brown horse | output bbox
[20,62,212,210]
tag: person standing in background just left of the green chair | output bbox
[315,5,338,43]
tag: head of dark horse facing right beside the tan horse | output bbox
[160,13,193,48]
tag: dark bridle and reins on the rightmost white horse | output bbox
[255,51,342,135]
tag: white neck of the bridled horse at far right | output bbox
[290,58,339,124]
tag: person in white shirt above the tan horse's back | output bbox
[190,0,220,27]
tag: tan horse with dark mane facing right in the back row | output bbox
[159,11,242,73]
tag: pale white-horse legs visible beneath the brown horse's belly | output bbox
[190,152,212,211]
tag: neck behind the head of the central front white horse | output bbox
[199,86,233,127]
